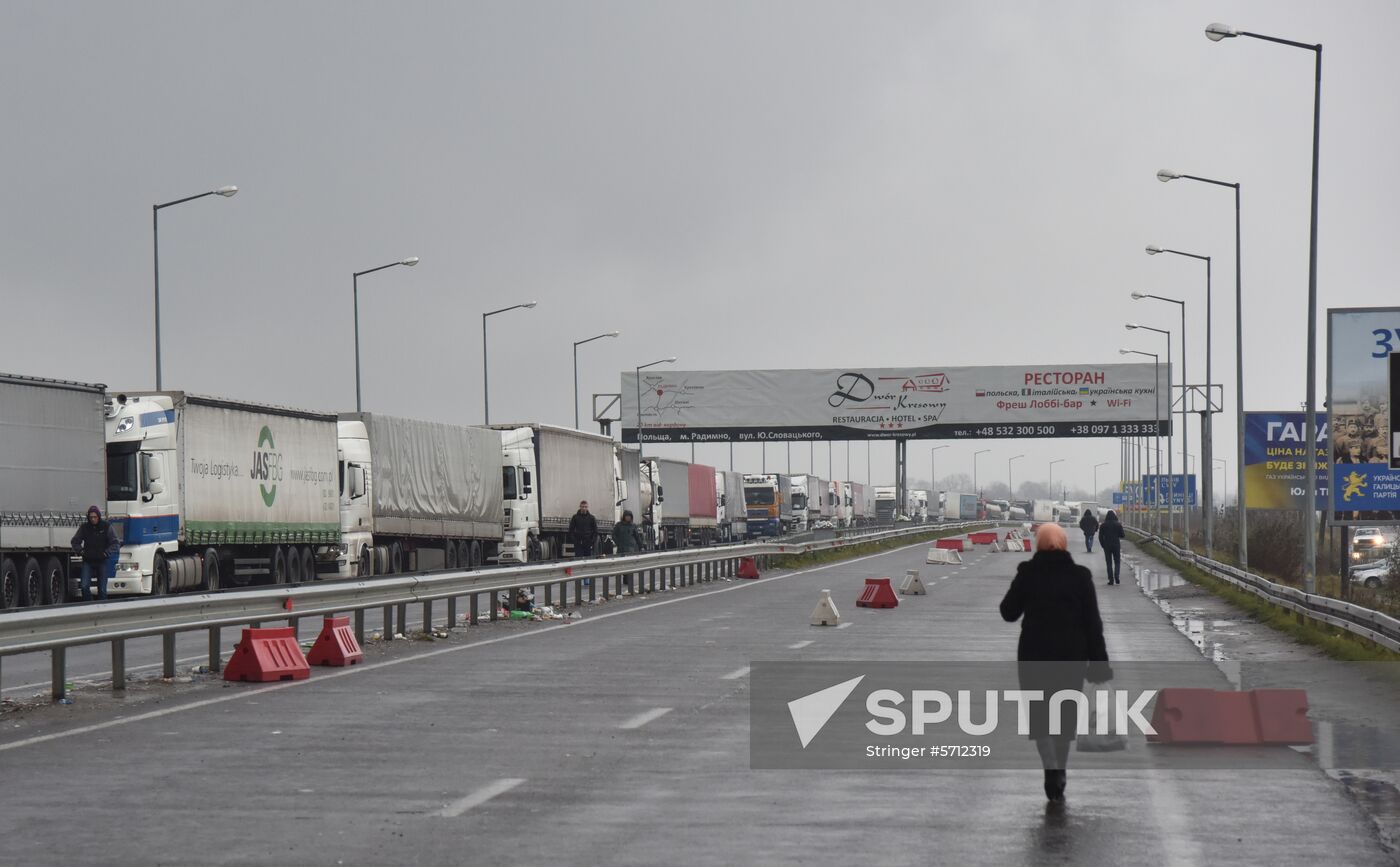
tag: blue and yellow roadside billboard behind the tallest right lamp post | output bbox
[1245,412,1329,511]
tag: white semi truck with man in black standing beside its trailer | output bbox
[493,424,619,564]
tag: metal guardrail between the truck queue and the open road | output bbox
[0,522,984,700]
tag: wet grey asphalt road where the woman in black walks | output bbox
[0,546,1392,866]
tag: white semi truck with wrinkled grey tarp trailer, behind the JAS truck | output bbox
[336,412,503,576]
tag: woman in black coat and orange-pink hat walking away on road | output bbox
[1001,524,1113,801]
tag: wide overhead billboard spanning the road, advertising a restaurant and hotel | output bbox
[620,364,1170,443]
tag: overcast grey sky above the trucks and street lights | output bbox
[0,0,1400,494]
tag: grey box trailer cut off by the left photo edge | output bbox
[0,374,107,609]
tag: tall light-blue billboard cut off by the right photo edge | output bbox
[1327,307,1400,524]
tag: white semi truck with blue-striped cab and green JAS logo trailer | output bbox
[106,391,340,595]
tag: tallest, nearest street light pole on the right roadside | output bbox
[1205,24,1322,592]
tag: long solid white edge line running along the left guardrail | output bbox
[0,542,923,752]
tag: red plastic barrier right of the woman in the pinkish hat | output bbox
[1148,689,1313,744]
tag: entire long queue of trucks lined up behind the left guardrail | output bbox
[0,374,896,609]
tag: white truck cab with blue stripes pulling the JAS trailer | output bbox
[105,395,181,595]
